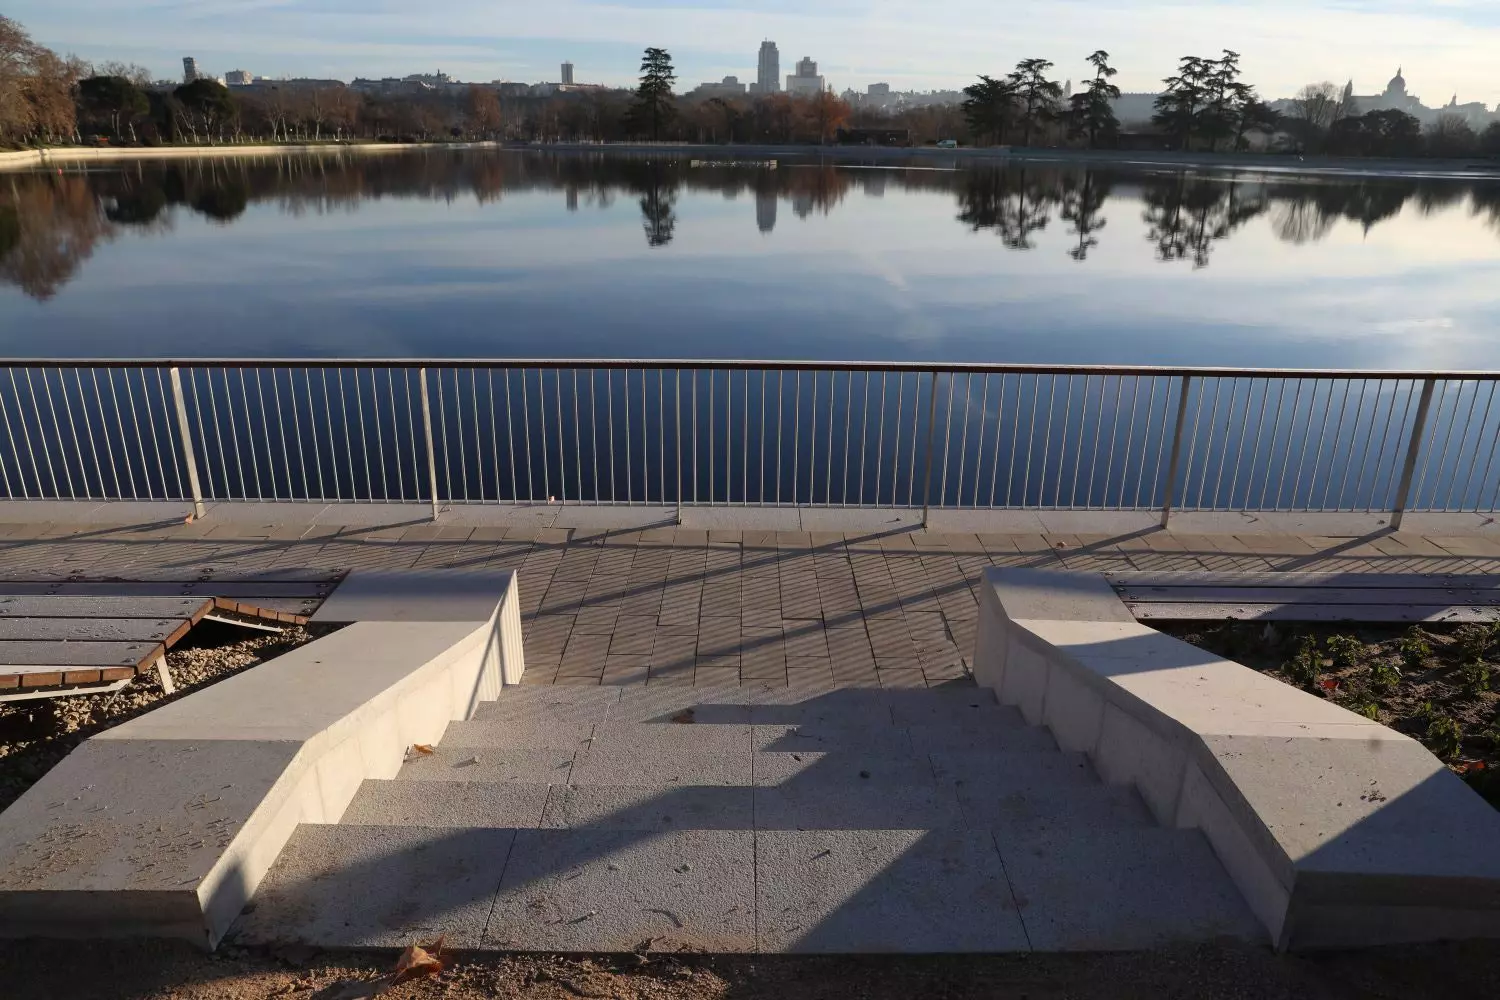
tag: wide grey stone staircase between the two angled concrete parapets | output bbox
[233,687,1265,952]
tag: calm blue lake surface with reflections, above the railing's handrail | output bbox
[0,151,1500,367]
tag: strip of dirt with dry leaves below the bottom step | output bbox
[0,942,1500,1000]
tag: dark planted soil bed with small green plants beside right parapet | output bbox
[1157,621,1500,808]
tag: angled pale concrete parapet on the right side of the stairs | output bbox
[974,570,1500,949]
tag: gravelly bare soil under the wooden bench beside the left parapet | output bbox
[0,622,338,815]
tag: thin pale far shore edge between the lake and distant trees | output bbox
[0,141,1500,180]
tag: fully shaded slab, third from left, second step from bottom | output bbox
[755,777,965,831]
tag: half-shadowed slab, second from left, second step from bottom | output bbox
[540,786,755,831]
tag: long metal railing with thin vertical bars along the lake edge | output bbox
[0,360,1500,526]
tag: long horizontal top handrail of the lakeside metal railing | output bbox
[0,358,1500,381]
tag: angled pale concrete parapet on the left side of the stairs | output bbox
[0,573,525,948]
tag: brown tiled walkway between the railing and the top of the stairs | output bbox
[0,517,1500,688]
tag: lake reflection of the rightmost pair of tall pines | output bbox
[1142,174,1266,268]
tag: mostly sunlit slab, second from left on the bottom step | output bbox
[485,829,755,954]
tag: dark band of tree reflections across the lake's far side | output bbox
[0,151,1500,301]
